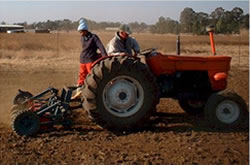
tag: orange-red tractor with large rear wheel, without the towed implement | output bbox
[82,27,248,130]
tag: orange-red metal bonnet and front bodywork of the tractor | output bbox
[147,53,231,91]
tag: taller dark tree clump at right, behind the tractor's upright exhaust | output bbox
[150,7,249,35]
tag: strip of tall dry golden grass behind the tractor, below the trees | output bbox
[0,31,249,69]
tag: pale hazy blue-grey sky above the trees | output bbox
[0,0,249,24]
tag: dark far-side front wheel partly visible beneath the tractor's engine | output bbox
[178,100,205,115]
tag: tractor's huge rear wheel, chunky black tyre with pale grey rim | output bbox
[82,56,159,131]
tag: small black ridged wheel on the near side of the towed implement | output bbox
[11,110,40,136]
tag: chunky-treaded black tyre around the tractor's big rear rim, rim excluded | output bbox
[83,56,159,130]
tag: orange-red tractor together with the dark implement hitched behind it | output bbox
[11,27,248,136]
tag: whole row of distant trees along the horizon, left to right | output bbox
[1,7,249,35]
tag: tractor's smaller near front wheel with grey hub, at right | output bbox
[205,93,248,128]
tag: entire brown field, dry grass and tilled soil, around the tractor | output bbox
[0,32,249,165]
